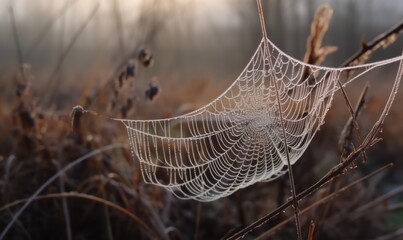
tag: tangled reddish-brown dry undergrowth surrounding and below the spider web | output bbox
[0,3,403,240]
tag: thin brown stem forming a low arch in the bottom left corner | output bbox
[0,192,159,239]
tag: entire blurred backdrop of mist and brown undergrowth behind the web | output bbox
[0,0,403,239]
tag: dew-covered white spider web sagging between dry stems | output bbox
[117,37,402,201]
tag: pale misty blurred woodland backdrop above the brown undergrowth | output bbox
[0,0,403,87]
